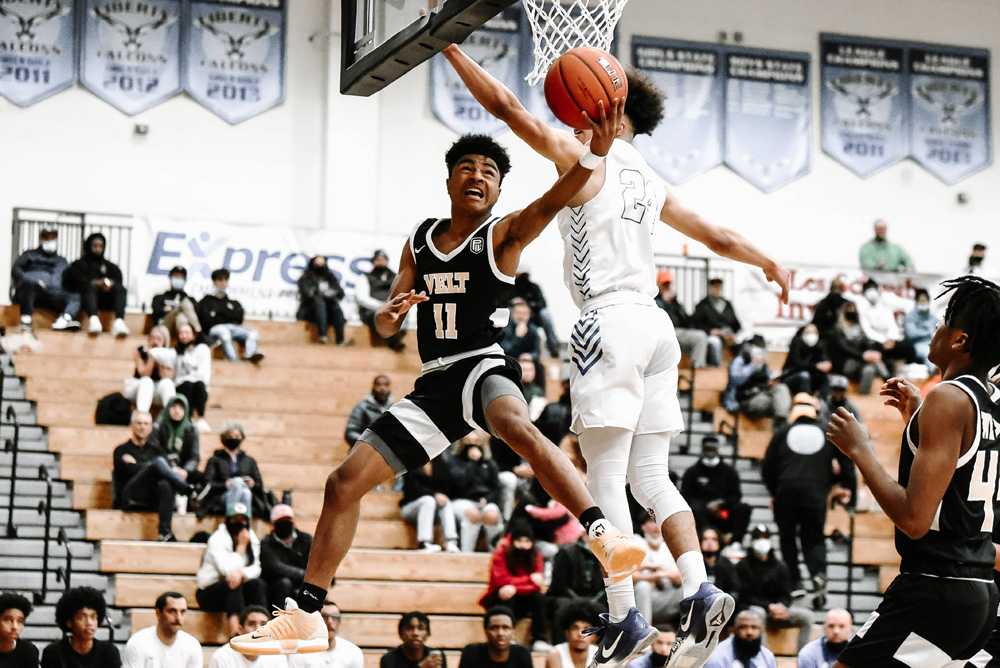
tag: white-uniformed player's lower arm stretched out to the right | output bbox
[660,196,790,303]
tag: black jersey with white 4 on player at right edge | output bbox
[896,376,1000,580]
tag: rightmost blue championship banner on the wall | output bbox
[908,45,992,185]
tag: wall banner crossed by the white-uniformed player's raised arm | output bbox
[430,7,527,135]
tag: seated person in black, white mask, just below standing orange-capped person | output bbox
[736,524,812,658]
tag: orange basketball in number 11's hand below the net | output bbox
[545,46,628,130]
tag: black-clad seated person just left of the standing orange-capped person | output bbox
[680,434,751,544]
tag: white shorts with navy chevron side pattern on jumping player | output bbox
[570,303,684,434]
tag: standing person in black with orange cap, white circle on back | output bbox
[761,394,854,596]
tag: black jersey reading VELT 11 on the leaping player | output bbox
[410,218,514,362]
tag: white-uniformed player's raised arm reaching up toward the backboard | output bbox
[444,44,586,173]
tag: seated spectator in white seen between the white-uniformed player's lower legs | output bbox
[632,513,683,624]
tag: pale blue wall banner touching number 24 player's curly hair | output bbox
[632,36,724,185]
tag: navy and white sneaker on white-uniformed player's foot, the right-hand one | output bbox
[666,582,736,668]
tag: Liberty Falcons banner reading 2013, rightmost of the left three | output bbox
[182,0,286,125]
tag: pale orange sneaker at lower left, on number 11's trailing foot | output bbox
[229,598,330,656]
